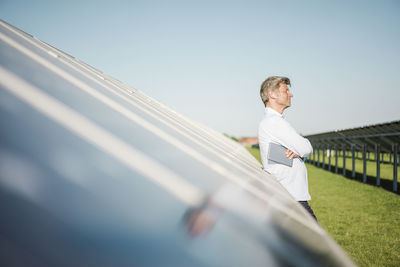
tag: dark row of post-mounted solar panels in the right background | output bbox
[306,121,400,192]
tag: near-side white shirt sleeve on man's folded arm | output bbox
[268,119,313,157]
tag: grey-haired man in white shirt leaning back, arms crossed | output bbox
[258,76,317,222]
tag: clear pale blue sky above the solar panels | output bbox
[0,0,400,137]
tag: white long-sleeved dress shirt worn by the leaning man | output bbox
[258,108,312,201]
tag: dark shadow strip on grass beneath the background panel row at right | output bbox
[307,161,400,195]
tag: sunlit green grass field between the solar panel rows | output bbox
[245,149,400,266]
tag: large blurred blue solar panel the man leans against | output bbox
[0,21,354,266]
